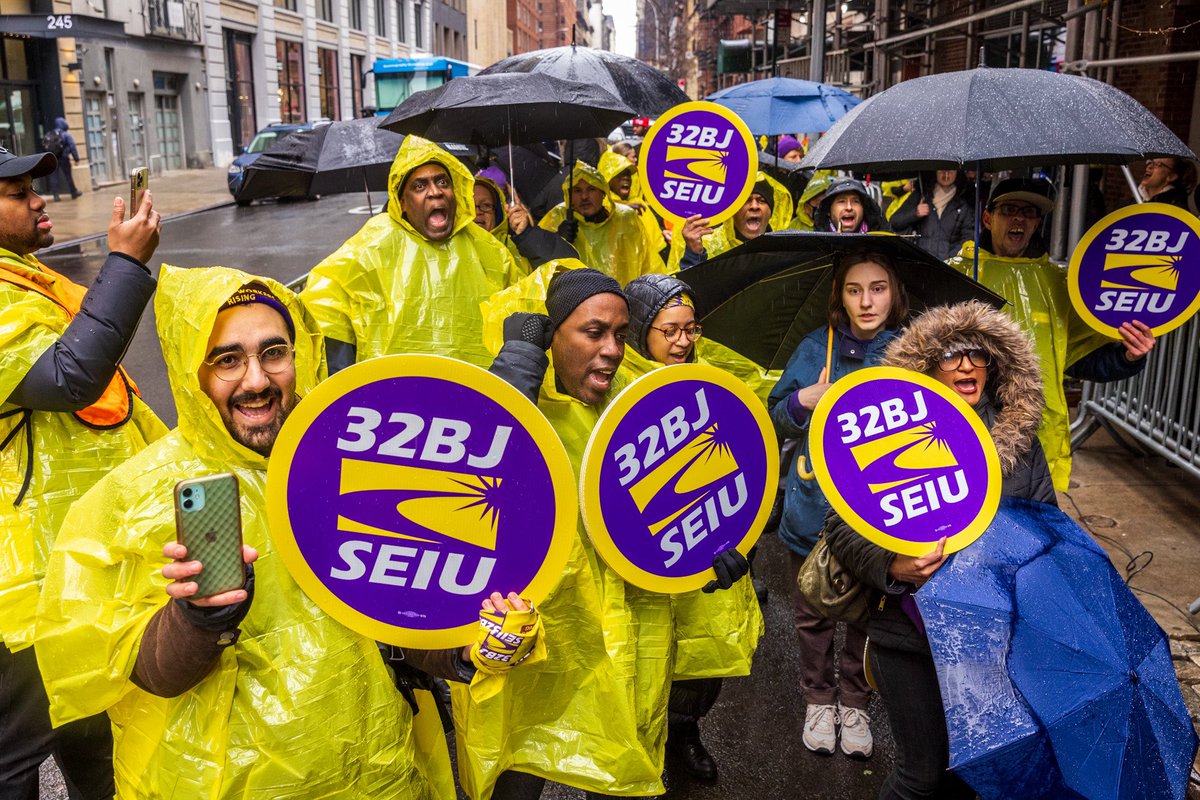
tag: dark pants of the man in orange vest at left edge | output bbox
[0,644,115,800]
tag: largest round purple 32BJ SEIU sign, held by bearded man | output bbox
[266,355,578,649]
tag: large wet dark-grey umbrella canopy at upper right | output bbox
[802,67,1196,172]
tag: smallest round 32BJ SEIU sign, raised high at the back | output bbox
[637,101,758,225]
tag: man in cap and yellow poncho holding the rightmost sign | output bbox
[949,178,1154,492]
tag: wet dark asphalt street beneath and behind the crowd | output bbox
[35,194,892,800]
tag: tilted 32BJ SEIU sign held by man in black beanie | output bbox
[580,365,779,593]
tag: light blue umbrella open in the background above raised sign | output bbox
[704,78,863,136]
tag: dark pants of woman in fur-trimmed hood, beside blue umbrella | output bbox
[871,642,976,800]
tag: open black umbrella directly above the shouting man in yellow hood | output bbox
[380,72,634,146]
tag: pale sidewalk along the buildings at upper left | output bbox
[46,167,233,251]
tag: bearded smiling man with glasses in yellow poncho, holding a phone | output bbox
[36,266,452,800]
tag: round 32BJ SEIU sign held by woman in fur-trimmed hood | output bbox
[809,367,1001,555]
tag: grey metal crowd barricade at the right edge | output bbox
[1070,317,1200,477]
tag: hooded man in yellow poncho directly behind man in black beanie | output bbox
[538,161,662,284]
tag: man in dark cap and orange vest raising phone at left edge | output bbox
[0,148,167,799]
